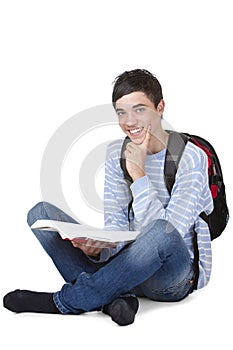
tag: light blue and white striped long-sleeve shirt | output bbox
[100,139,213,288]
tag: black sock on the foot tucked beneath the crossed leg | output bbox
[103,296,139,326]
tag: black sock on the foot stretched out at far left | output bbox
[3,289,60,314]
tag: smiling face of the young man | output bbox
[115,91,164,144]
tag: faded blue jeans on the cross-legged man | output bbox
[28,202,194,314]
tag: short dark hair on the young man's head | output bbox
[112,69,163,108]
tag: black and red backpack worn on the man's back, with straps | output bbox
[120,130,229,240]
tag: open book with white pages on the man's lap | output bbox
[31,220,140,243]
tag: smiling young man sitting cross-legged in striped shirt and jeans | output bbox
[4,69,213,325]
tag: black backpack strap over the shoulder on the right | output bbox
[164,130,189,194]
